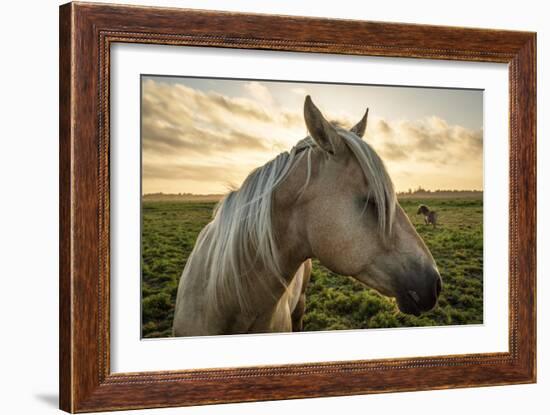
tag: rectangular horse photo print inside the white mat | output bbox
[141,75,483,338]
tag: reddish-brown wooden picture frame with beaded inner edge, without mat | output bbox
[59,3,536,412]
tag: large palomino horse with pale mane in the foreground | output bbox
[173,96,441,337]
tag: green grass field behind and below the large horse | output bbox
[142,197,483,337]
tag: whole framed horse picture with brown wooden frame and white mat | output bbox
[60,3,536,412]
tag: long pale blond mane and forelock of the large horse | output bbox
[190,126,396,312]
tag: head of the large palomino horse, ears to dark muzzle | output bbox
[278,96,441,315]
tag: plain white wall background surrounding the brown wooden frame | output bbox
[0,0,550,415]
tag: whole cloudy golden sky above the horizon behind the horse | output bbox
[141,75,483,194]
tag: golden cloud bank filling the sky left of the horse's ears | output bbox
[141,79,305,193]
